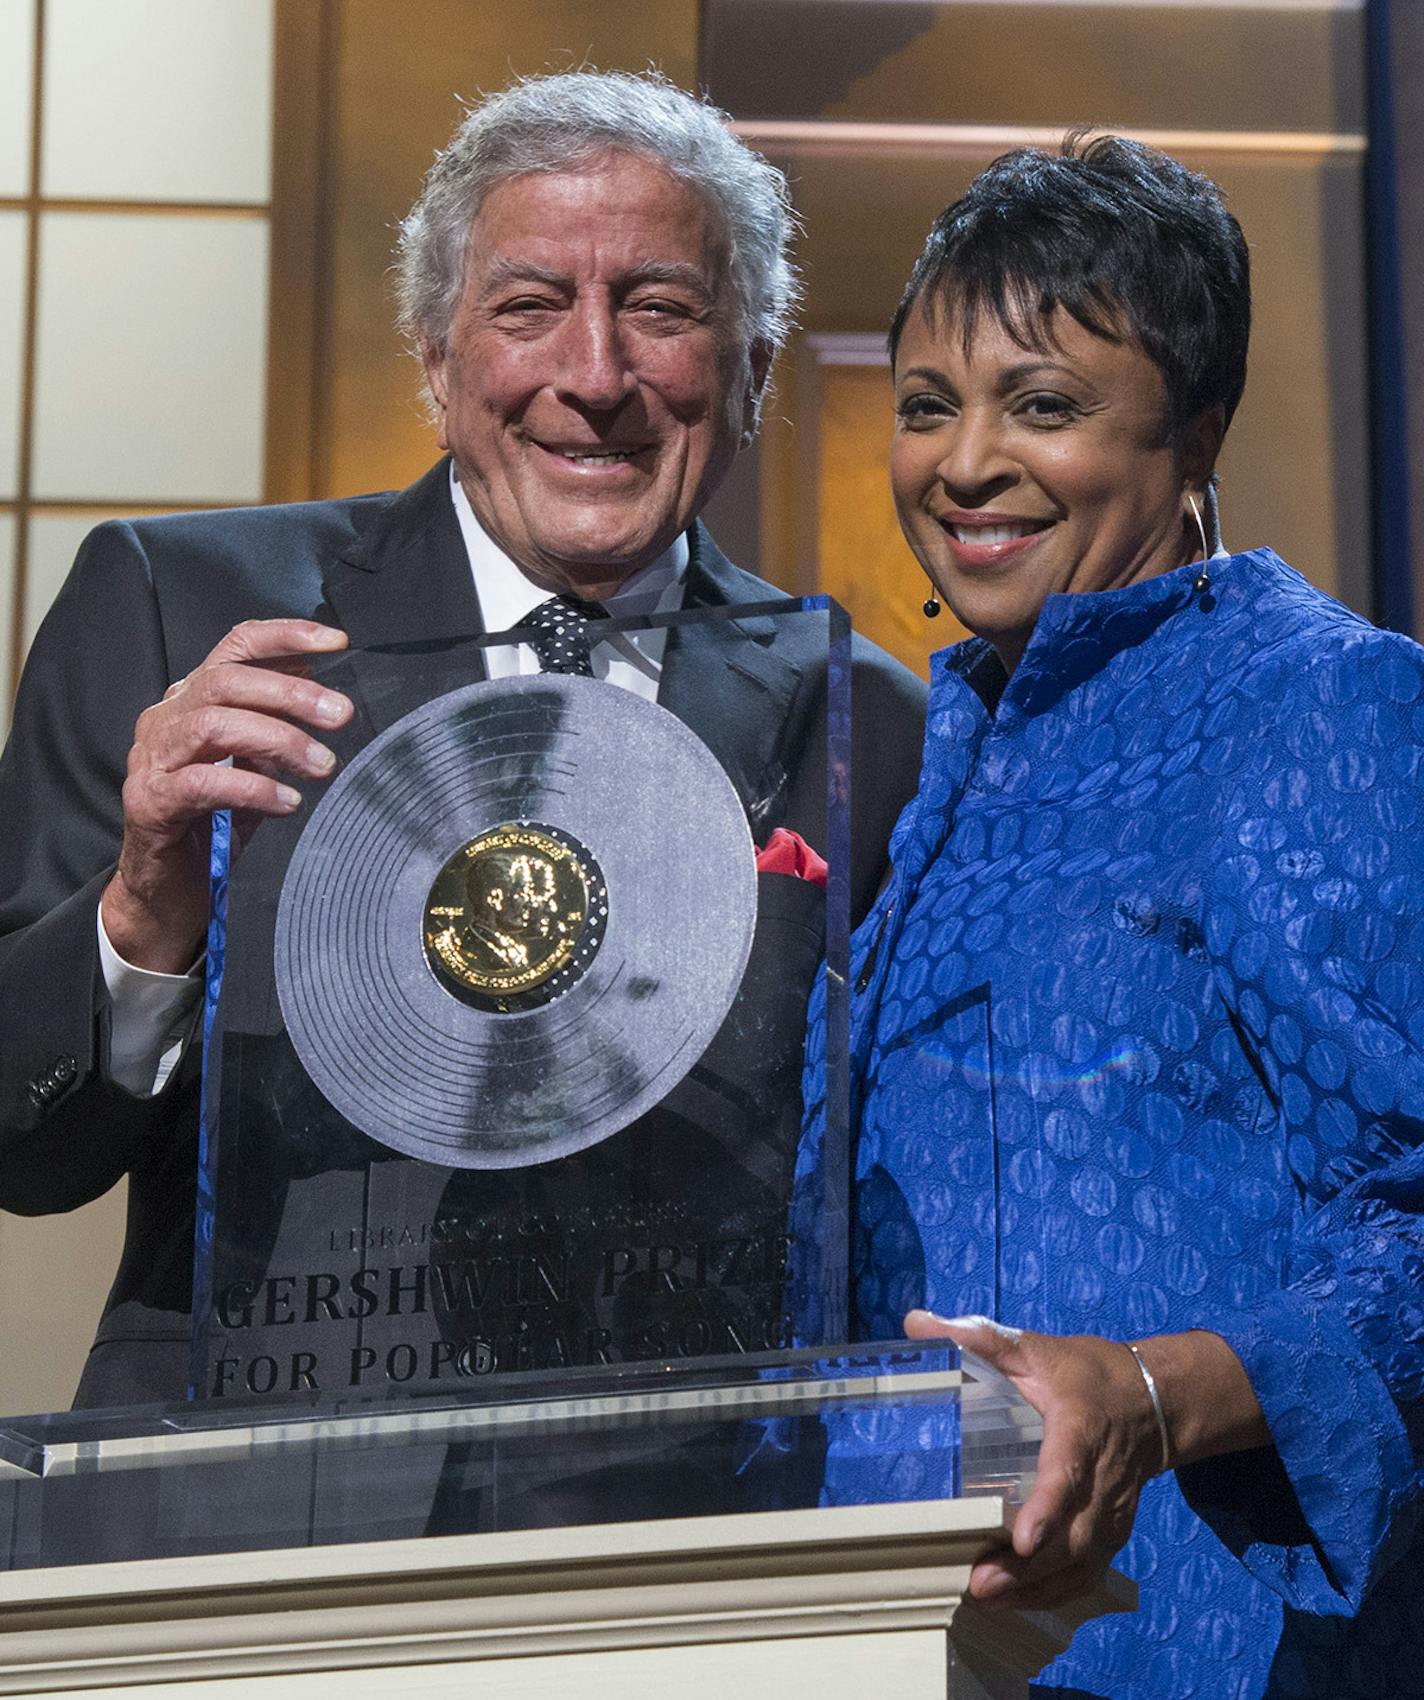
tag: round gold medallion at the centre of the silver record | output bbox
[421,821,590,998]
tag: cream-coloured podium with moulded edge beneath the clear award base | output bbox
[0,1499,1133,1700]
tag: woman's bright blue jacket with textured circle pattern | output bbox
[797,549,1424,1700]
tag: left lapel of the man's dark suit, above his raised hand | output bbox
[318,459,484,733]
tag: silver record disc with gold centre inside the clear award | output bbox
[275,675,756,1168]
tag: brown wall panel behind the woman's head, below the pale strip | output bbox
[768,139,1370,610]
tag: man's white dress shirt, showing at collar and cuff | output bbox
[99,468,688,1097]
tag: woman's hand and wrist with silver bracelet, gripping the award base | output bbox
[906,1311,1269,1610]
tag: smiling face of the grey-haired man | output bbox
[423,153,765,597]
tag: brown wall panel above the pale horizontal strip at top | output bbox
[702,0,1373,133]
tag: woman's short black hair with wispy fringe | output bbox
[889,131,1251,435]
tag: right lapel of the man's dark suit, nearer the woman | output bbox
[658,522,800,831]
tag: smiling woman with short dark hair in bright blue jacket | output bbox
[802,138,1424,1700]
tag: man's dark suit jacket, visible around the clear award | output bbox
[0,461,924,1404]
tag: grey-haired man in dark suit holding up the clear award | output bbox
[0,73,923,1404]
